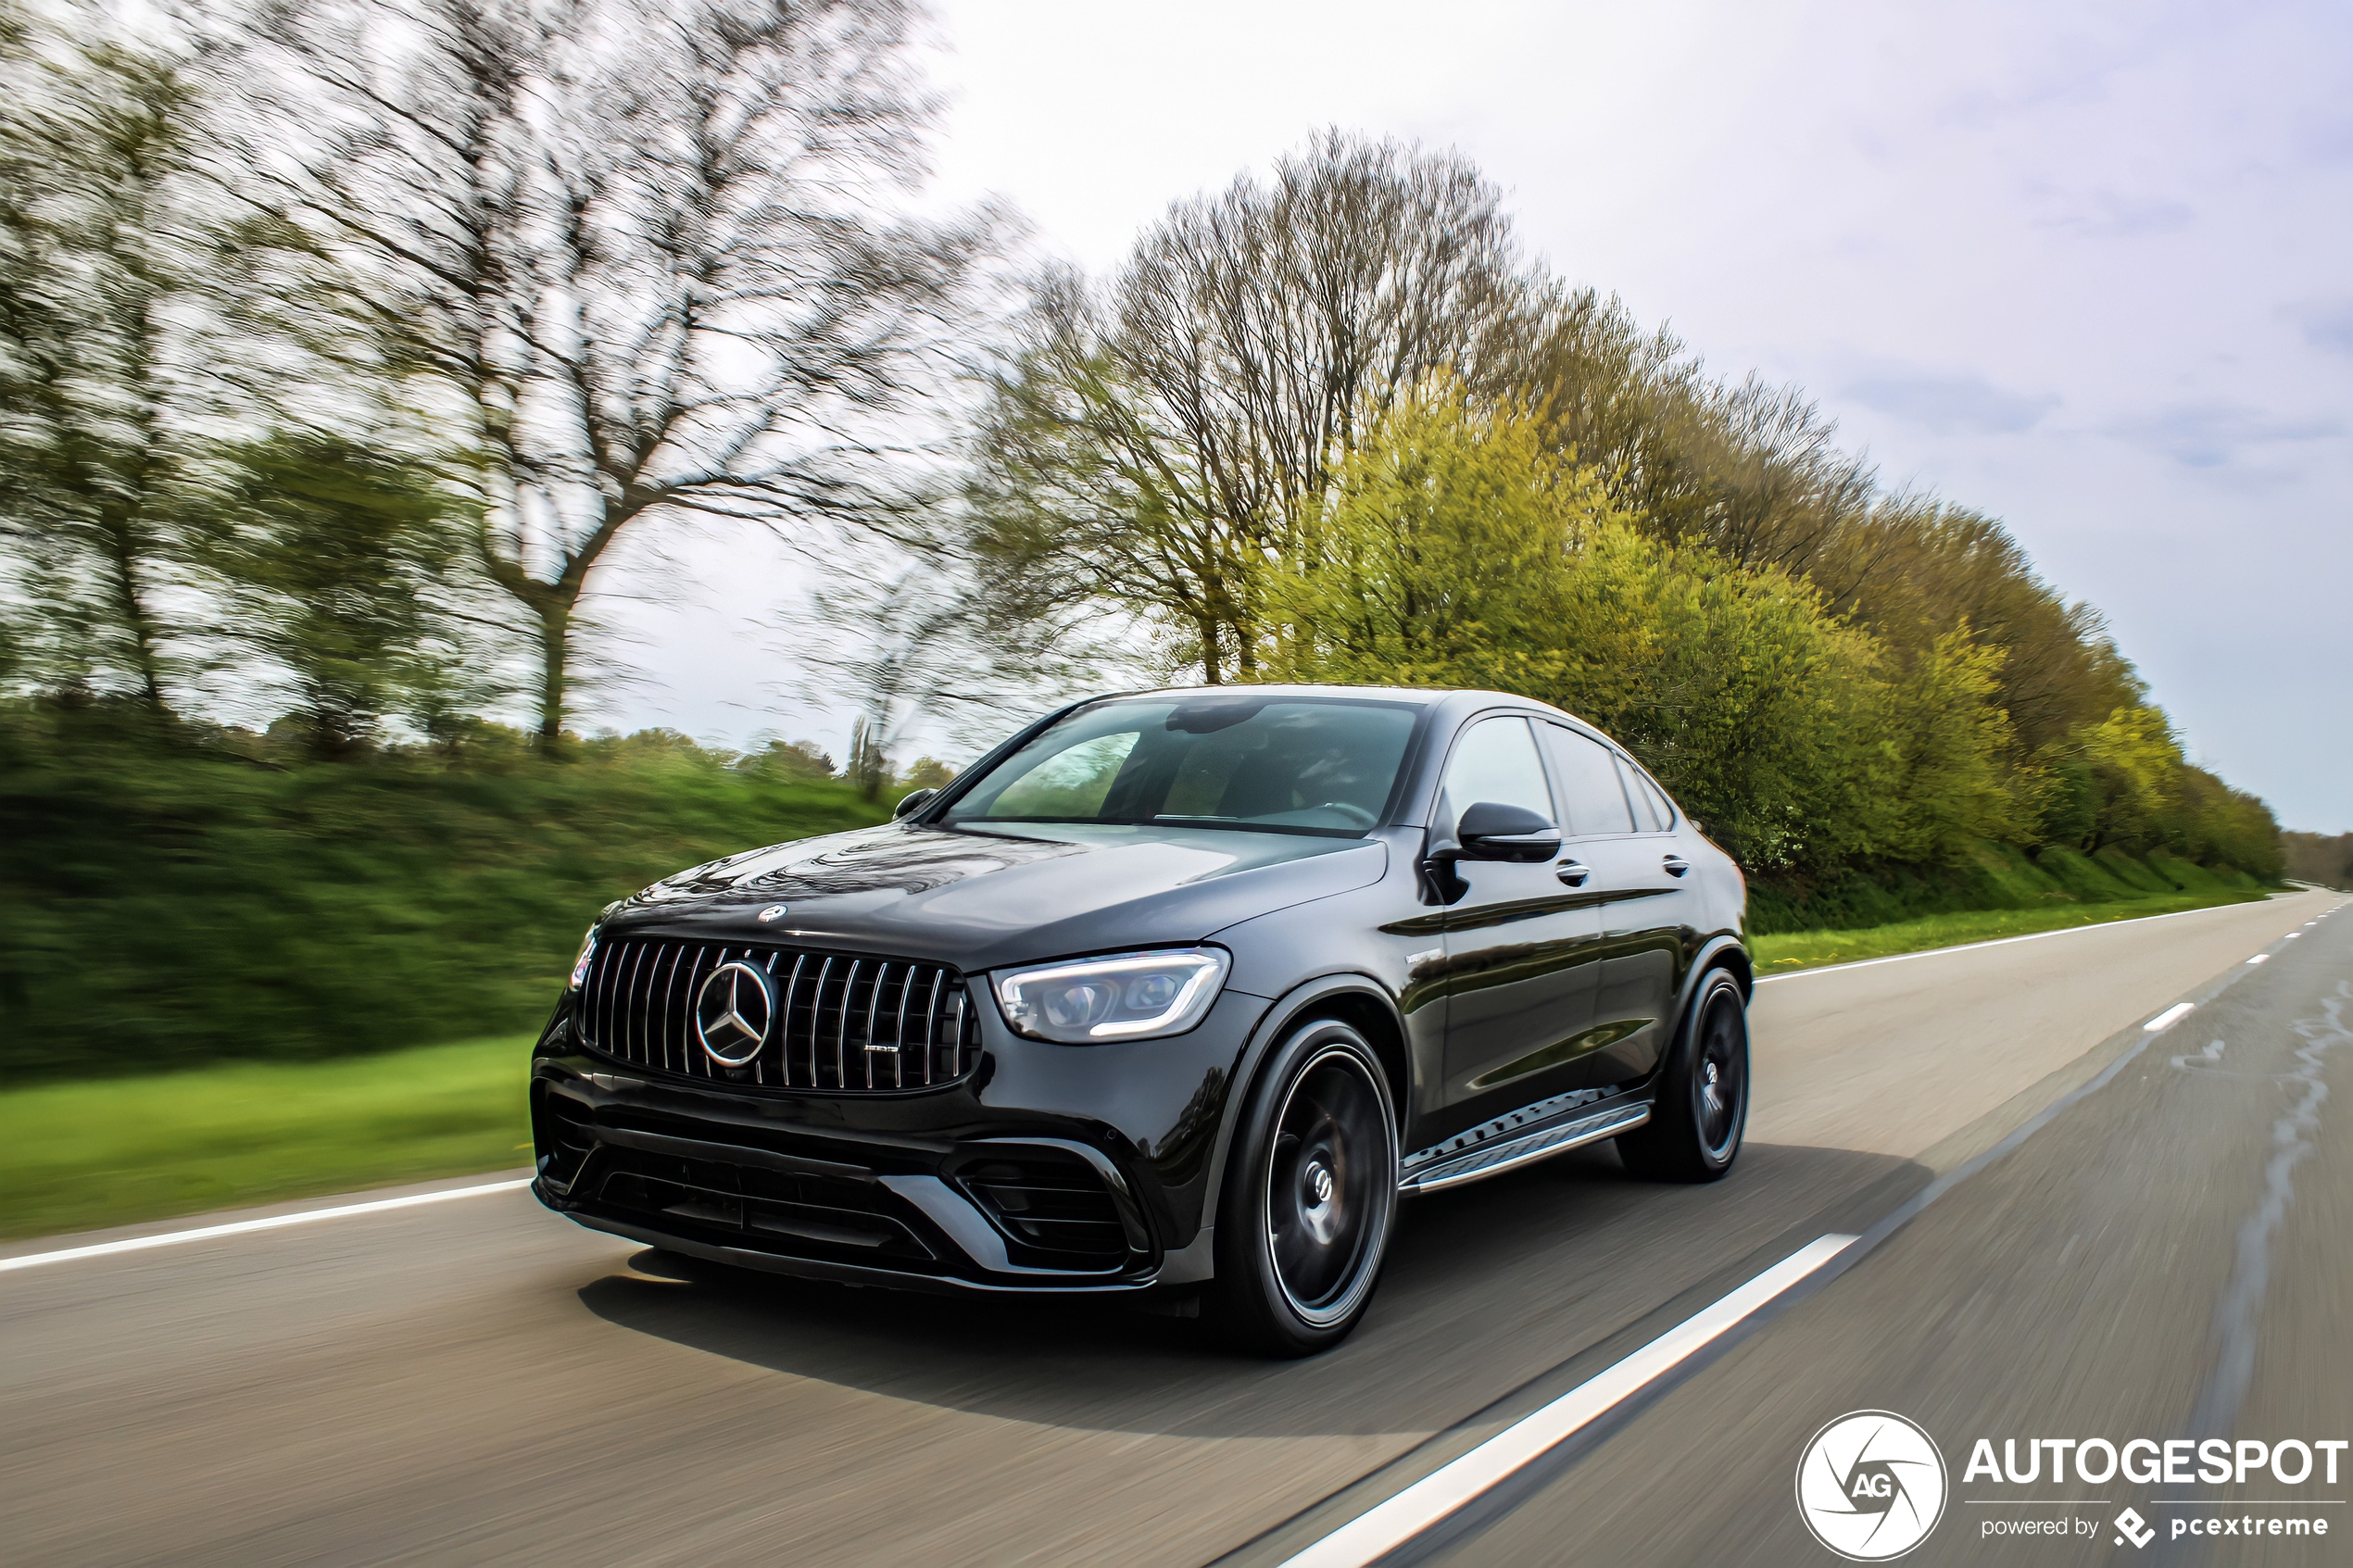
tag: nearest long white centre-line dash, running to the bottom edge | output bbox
[1282,1236,1855,1568]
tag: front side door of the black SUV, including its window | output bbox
[1435,717,1600,1131]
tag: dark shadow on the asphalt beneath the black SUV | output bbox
[579,1145,1927,1436]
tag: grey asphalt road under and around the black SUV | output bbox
[0,894,2353,1565]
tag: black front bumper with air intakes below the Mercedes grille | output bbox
[532,992,1266,1293]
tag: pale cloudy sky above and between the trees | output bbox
[588,0,2353,833]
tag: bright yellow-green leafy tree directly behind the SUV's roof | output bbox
[1266,381,1885,868]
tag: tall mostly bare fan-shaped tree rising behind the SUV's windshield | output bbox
[972,132,1532,684]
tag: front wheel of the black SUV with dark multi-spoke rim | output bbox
[1214,1018,1398,1357]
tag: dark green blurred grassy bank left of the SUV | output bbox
[0,710,880,1082]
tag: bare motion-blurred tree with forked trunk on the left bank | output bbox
[250,0,993,746]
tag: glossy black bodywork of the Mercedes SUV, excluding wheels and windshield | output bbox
[532,686,1748,1290]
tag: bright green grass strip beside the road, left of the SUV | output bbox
[0,1035,532,1236]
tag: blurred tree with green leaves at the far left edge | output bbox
[0,7,212,715]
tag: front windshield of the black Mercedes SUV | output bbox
[941,694,1419,834]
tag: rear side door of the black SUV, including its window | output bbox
[1539,721,1692,1088]
